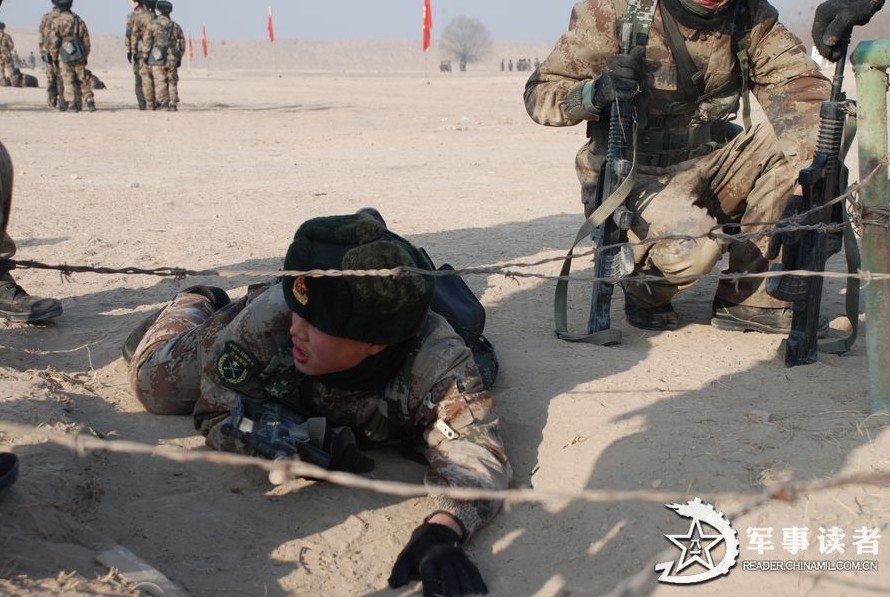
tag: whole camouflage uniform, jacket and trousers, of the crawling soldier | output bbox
[130,284,512,533]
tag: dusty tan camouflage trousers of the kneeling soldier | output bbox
[578,124,797,308]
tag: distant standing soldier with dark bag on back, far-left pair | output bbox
[49,0,96,112]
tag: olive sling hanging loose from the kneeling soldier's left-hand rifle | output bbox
[553,123,637,346]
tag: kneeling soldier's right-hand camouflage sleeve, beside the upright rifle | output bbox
[749,1,831,171]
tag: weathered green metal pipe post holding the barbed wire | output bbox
[850,40,890,412]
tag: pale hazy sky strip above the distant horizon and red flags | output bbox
[0,0,817,42]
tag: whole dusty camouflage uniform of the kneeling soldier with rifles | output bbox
[525,0,831,307]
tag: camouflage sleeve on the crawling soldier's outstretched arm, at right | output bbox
[411,315,513,538]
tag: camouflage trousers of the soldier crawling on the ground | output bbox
[130,292,244,415]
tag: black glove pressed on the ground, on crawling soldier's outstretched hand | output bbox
[389,522,488,597]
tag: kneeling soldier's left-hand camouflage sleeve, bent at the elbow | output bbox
[524,0,627,126]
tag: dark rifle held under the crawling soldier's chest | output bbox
[222,395,374,473]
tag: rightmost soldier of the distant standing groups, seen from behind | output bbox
[142,0,185,112]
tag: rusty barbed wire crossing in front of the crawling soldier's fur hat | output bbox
[7,156,890,284]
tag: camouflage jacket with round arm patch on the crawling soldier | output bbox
[194,284,512,534]
